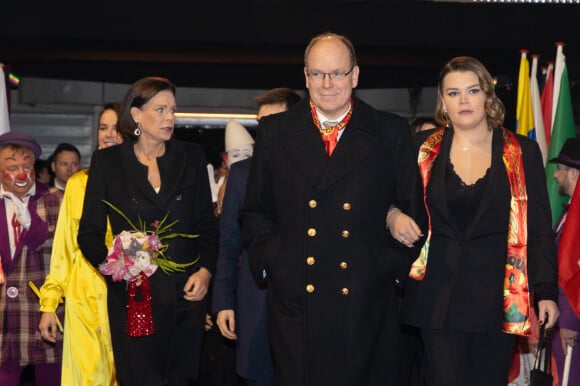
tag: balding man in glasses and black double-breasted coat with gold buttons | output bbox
[242,33,416,386]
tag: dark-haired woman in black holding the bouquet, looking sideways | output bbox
[78,77,217,386]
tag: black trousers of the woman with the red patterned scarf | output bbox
[421,328,515,386]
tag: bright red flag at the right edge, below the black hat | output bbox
[558,183,580,318]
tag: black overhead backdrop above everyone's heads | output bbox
[0,0,580,89]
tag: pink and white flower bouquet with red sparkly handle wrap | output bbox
[99,200,198,337]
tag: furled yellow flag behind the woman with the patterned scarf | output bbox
[516,50,536,140]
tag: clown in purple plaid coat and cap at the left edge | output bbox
[0,132,62,386]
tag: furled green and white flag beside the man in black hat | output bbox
[546,43,576,224]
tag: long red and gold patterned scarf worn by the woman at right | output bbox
[409,128,531,335]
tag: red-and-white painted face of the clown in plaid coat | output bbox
[0,147,34,197]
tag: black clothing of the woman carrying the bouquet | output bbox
[78,140,217,386]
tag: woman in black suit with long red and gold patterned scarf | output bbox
[389,57,559,386]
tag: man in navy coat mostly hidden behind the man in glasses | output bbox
[212,88,300,386]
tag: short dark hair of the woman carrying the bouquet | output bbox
[117,76,175,140]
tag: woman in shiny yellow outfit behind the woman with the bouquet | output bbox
[39,103,122,386]
